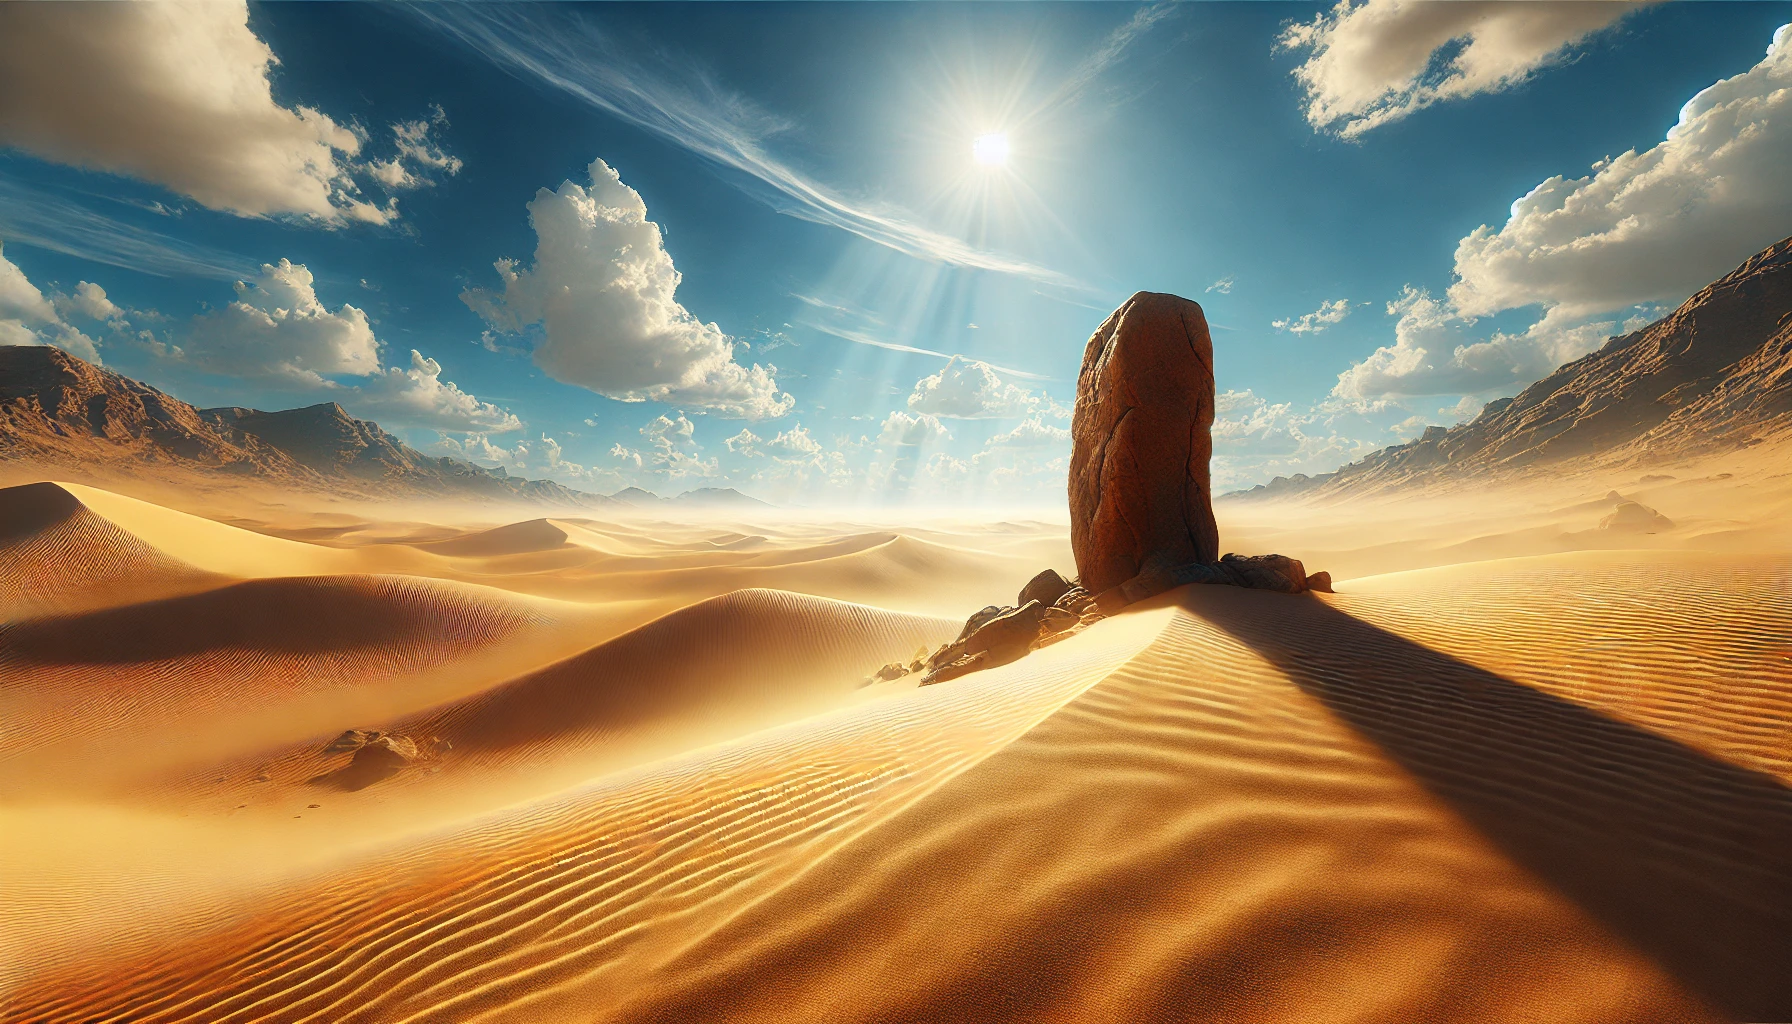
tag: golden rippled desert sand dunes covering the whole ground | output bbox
[0,447,1792,1024]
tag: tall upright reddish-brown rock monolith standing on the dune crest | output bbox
[1070,292,1220,594]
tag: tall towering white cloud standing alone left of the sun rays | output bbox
[461,160,796,420]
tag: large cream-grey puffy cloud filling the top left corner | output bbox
[0,0,459,224]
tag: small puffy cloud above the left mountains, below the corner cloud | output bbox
[181,258,380,387]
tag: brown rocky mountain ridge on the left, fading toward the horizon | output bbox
[0,346,769,511]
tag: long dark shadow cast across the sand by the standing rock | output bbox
[1183,586,1792,1020]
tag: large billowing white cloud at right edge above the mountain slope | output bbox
[1450,25,1792,316]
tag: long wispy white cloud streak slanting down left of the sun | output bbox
[410,5,1082,291]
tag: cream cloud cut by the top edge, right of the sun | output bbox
[1279,0,1638,138]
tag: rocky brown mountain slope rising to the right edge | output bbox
[1224,239,1792,497]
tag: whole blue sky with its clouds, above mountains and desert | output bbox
[0,0,1792,506]
